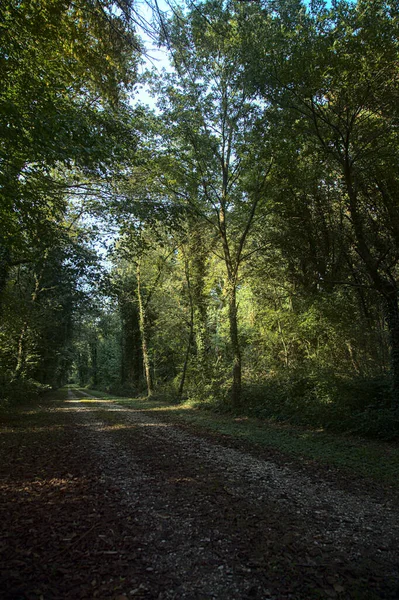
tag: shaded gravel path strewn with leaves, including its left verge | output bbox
[0,390,399,600]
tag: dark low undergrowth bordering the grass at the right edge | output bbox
[236,370,399,439]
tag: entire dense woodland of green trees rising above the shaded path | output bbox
[0,0,399,438]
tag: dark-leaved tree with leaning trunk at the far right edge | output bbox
[243,0,399,406]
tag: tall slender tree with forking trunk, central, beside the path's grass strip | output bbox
[148,2,271,406]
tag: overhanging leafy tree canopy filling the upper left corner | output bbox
[0,0,139,308]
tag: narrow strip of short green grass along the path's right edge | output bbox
[65,386,399,491]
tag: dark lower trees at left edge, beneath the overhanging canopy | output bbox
[0,223,95,396]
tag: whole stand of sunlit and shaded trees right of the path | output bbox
[80,2,399,428]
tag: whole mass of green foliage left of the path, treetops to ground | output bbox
[0,0,138,399]
